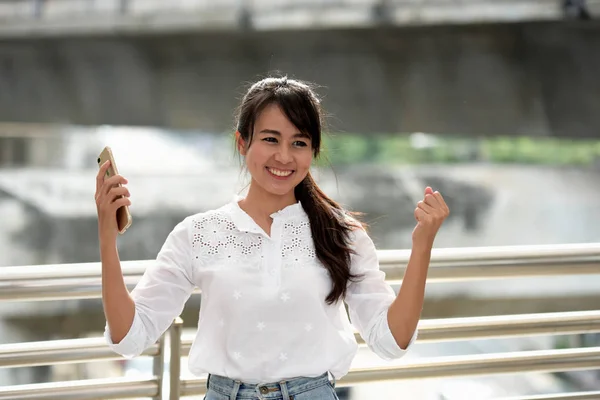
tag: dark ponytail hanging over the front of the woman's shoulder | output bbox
[294,172,366,305]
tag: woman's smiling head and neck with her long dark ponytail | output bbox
[236,78,366,304]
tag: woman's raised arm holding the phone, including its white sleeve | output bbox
[95,161,195,357]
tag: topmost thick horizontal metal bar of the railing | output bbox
[0,243,600,301]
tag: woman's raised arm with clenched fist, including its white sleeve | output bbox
[345,188,448,360]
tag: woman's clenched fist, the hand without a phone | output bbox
[412,186,450,249]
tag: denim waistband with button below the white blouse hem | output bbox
[206,372,335,400]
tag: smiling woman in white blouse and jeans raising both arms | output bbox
[96,78,448,400]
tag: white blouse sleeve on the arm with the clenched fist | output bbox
[346,228,418,360]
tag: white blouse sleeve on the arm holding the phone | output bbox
[104,217,195,358]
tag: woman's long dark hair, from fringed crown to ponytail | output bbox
[236,77,363,304]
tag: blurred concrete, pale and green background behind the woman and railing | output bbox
[0,0,600,400]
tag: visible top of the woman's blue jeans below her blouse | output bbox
[204,372,339,400]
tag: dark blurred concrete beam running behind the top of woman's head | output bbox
[0,22,600,137]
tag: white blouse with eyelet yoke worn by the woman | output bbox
[105,201,417,383]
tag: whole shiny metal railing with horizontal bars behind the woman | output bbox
[0,244,600,400]
